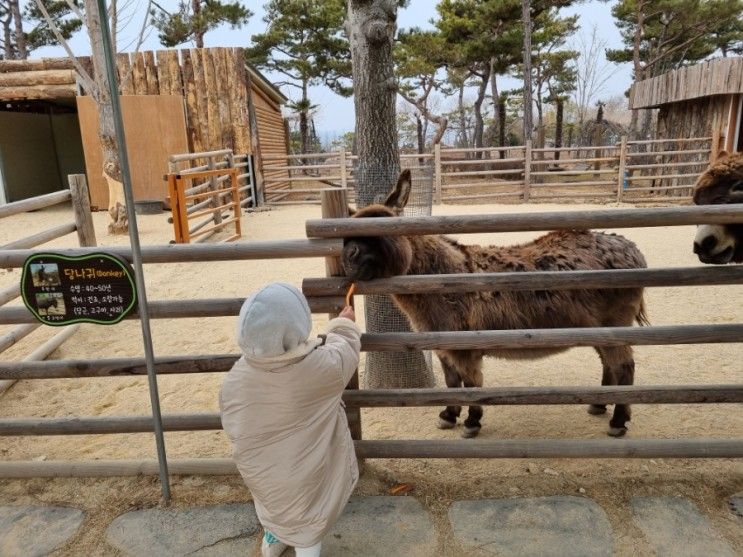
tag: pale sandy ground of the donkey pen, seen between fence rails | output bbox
[0,199,743,555]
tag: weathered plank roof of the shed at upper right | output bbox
[630,56,743,108]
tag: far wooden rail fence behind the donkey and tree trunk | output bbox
[263,137,714,205]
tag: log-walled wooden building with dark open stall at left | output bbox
[0,48,288,208]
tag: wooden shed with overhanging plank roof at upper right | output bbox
[630,56,743,157]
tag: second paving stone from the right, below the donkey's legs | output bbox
[449,496,613,557]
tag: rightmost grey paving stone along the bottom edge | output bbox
[630,497,733,557]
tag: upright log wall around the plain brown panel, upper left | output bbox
[117,48,258,153]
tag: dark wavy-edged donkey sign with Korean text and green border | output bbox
[21,253,137,326]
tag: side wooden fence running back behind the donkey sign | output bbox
[0,174,96,396]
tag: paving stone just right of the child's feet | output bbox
[322,496,436,557]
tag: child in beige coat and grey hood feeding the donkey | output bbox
[220,283,361,557]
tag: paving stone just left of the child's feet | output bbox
[106,503,261,557]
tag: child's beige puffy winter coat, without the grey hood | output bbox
[220,318,361,547]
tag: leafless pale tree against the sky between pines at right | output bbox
[573,25,614,128]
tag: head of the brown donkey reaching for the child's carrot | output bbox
[341,170,412,282]
